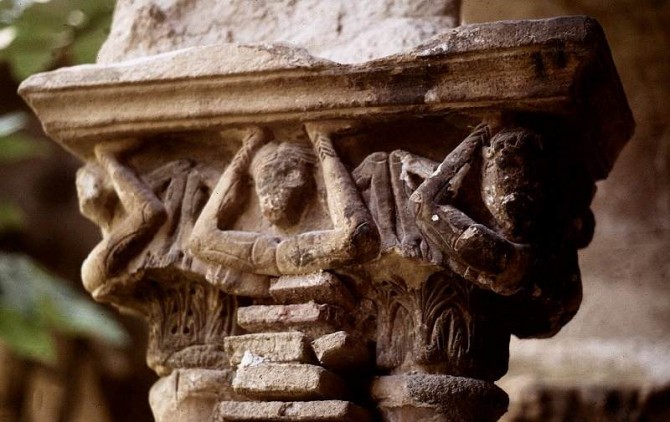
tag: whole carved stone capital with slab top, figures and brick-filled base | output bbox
[20,4,633,421]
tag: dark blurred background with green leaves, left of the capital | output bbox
[0,0,155,422]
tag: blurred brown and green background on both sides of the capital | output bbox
[0,0,670,422]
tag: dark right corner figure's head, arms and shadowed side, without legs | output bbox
[410,121,594,337]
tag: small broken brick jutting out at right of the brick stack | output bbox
[312,331,370,370]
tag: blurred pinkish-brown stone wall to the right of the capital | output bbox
[464,0,670,421]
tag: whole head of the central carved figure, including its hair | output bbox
[250,141,316,228]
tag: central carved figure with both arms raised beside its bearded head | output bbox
[190,124,379,276]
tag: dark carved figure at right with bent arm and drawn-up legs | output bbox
[353,125,541,294]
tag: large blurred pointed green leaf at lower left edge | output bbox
[0,253,128,363]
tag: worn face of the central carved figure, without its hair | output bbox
[254,146,311,228]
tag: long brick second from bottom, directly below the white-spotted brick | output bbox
[232,363,347,400]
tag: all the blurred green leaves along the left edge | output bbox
[0,0,128,363]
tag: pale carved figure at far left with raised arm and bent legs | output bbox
[77,140,216,292]
